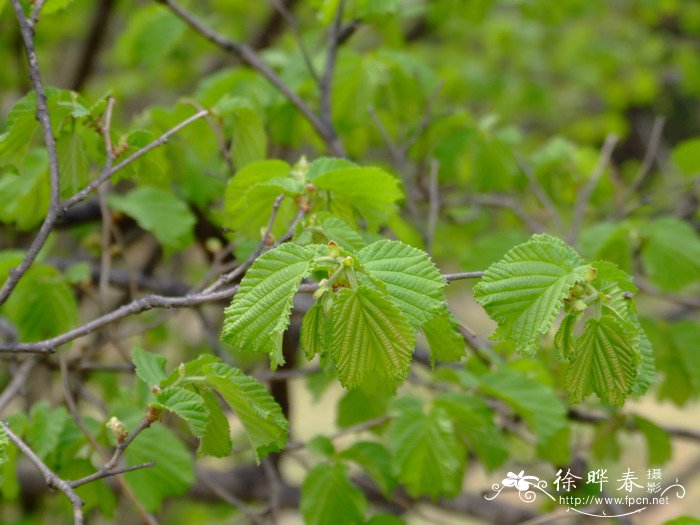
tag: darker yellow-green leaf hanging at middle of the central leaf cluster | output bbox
[331,286,415,390]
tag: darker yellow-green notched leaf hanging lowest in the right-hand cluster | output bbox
[566,314,640,406]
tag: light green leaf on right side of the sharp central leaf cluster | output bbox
[358,239,445,328]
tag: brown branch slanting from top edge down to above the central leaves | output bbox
[157,0,345,157]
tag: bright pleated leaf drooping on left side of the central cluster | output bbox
[221,243,312,368]
